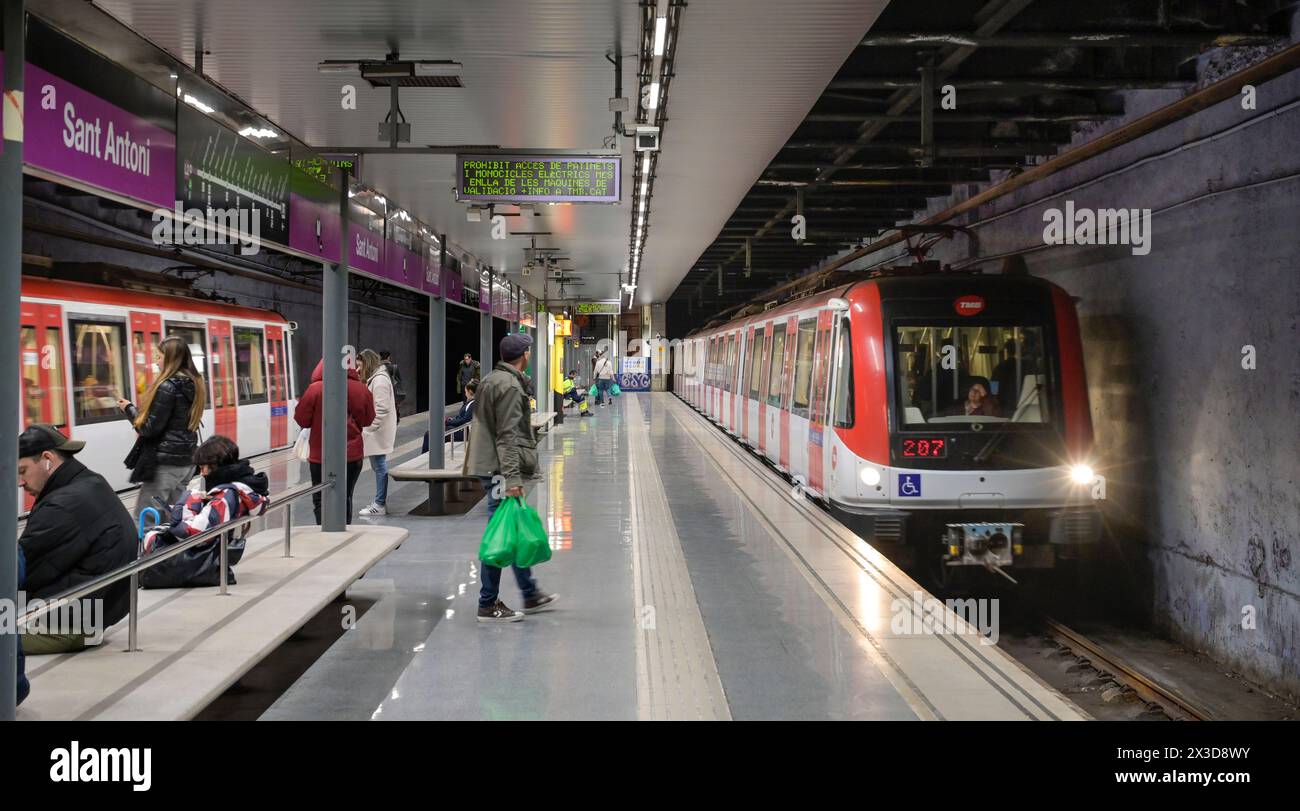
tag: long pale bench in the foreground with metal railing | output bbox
[18,525,407,721]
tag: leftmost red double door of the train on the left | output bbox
[18,302,72,511]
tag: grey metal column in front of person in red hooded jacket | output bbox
[321,169,356,532]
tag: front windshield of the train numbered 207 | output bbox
[894,325,1053,430]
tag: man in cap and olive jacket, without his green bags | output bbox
[464,333,556,623]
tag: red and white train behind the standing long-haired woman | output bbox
[18,277,298,496]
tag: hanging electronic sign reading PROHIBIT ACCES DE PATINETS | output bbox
[456,155,621,203]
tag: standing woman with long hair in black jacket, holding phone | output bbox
[117,335,208,521]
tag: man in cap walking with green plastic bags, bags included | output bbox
[464,333,559,623]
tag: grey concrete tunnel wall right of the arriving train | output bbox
[832,50,1300,698]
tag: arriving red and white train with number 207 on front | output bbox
[673,270,1101,584]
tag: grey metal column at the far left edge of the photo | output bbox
[0,0,26,721]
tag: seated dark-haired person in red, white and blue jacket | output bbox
[140,435,270,589]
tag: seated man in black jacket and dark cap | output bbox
[18,424,137,655]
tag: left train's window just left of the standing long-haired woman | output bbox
[69,318,131,425]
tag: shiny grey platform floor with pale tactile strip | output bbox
[261,393,1086,720]
